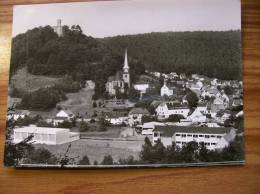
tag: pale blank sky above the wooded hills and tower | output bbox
[13,0,241,38]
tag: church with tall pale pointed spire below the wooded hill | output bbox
[106,49,130,95]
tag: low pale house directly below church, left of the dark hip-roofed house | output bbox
[105,111,128,125]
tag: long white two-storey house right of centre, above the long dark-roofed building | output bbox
[155,102,190,119]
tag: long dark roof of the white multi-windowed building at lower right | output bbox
[154,126,231,137]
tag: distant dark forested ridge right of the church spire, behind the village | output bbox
[101,31,242,79]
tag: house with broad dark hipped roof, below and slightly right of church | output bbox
[128,107,150,127]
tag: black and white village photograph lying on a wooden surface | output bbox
[4,0,245,168]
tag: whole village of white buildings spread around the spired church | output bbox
[8,50,243,161]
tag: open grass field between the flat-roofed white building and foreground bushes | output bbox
[35,139,143,164]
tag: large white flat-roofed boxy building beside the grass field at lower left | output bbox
[13,125,79,145]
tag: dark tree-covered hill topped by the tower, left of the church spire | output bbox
[11,25,144,97]
